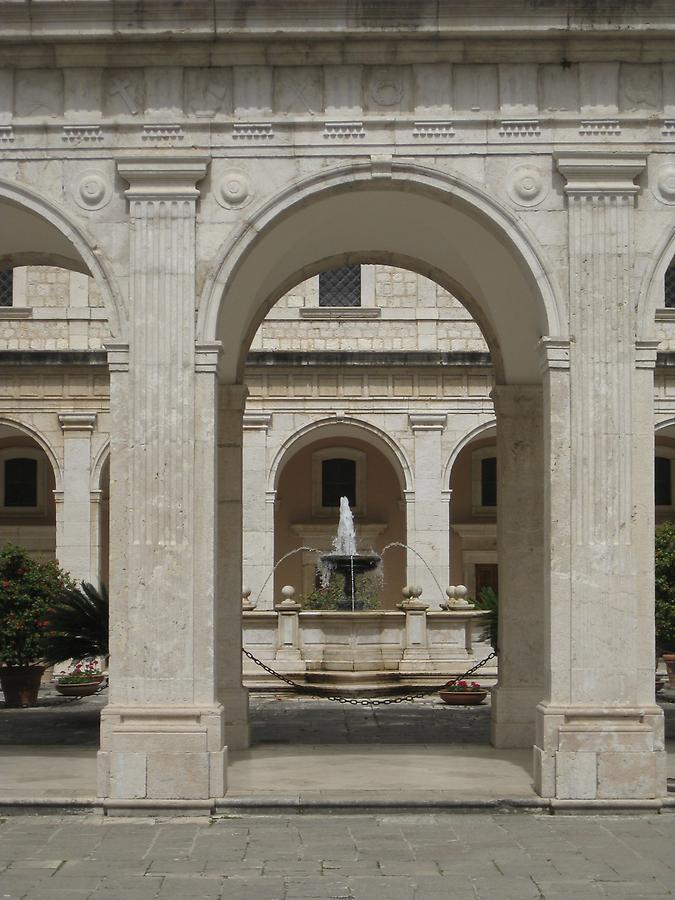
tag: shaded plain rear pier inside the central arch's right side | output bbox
[492,385,544,747]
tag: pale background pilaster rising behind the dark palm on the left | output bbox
[56,412,98,582]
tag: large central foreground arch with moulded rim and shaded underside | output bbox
[198,162,567,384]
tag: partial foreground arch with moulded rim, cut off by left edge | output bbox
[0,179,127,337]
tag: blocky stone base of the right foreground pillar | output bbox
[534,704,666,800]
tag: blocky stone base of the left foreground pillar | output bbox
[98,706,227,814]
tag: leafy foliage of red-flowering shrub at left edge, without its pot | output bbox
[0,544,74,666]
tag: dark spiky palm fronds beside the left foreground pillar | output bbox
[44,581,109,664]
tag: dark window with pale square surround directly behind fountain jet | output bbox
[312,447,366,516]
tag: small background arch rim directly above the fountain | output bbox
[267,416,413,492]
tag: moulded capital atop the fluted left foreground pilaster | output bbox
[117,154,211,200]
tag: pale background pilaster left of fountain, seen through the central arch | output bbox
[242,412,274,609]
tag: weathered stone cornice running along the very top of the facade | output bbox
[5,0,675,43]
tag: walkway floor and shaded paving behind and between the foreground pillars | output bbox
[0,689,675,811]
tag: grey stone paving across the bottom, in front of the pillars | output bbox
[0,813,675,900]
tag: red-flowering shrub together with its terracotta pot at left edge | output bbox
[0,544,73,708]
